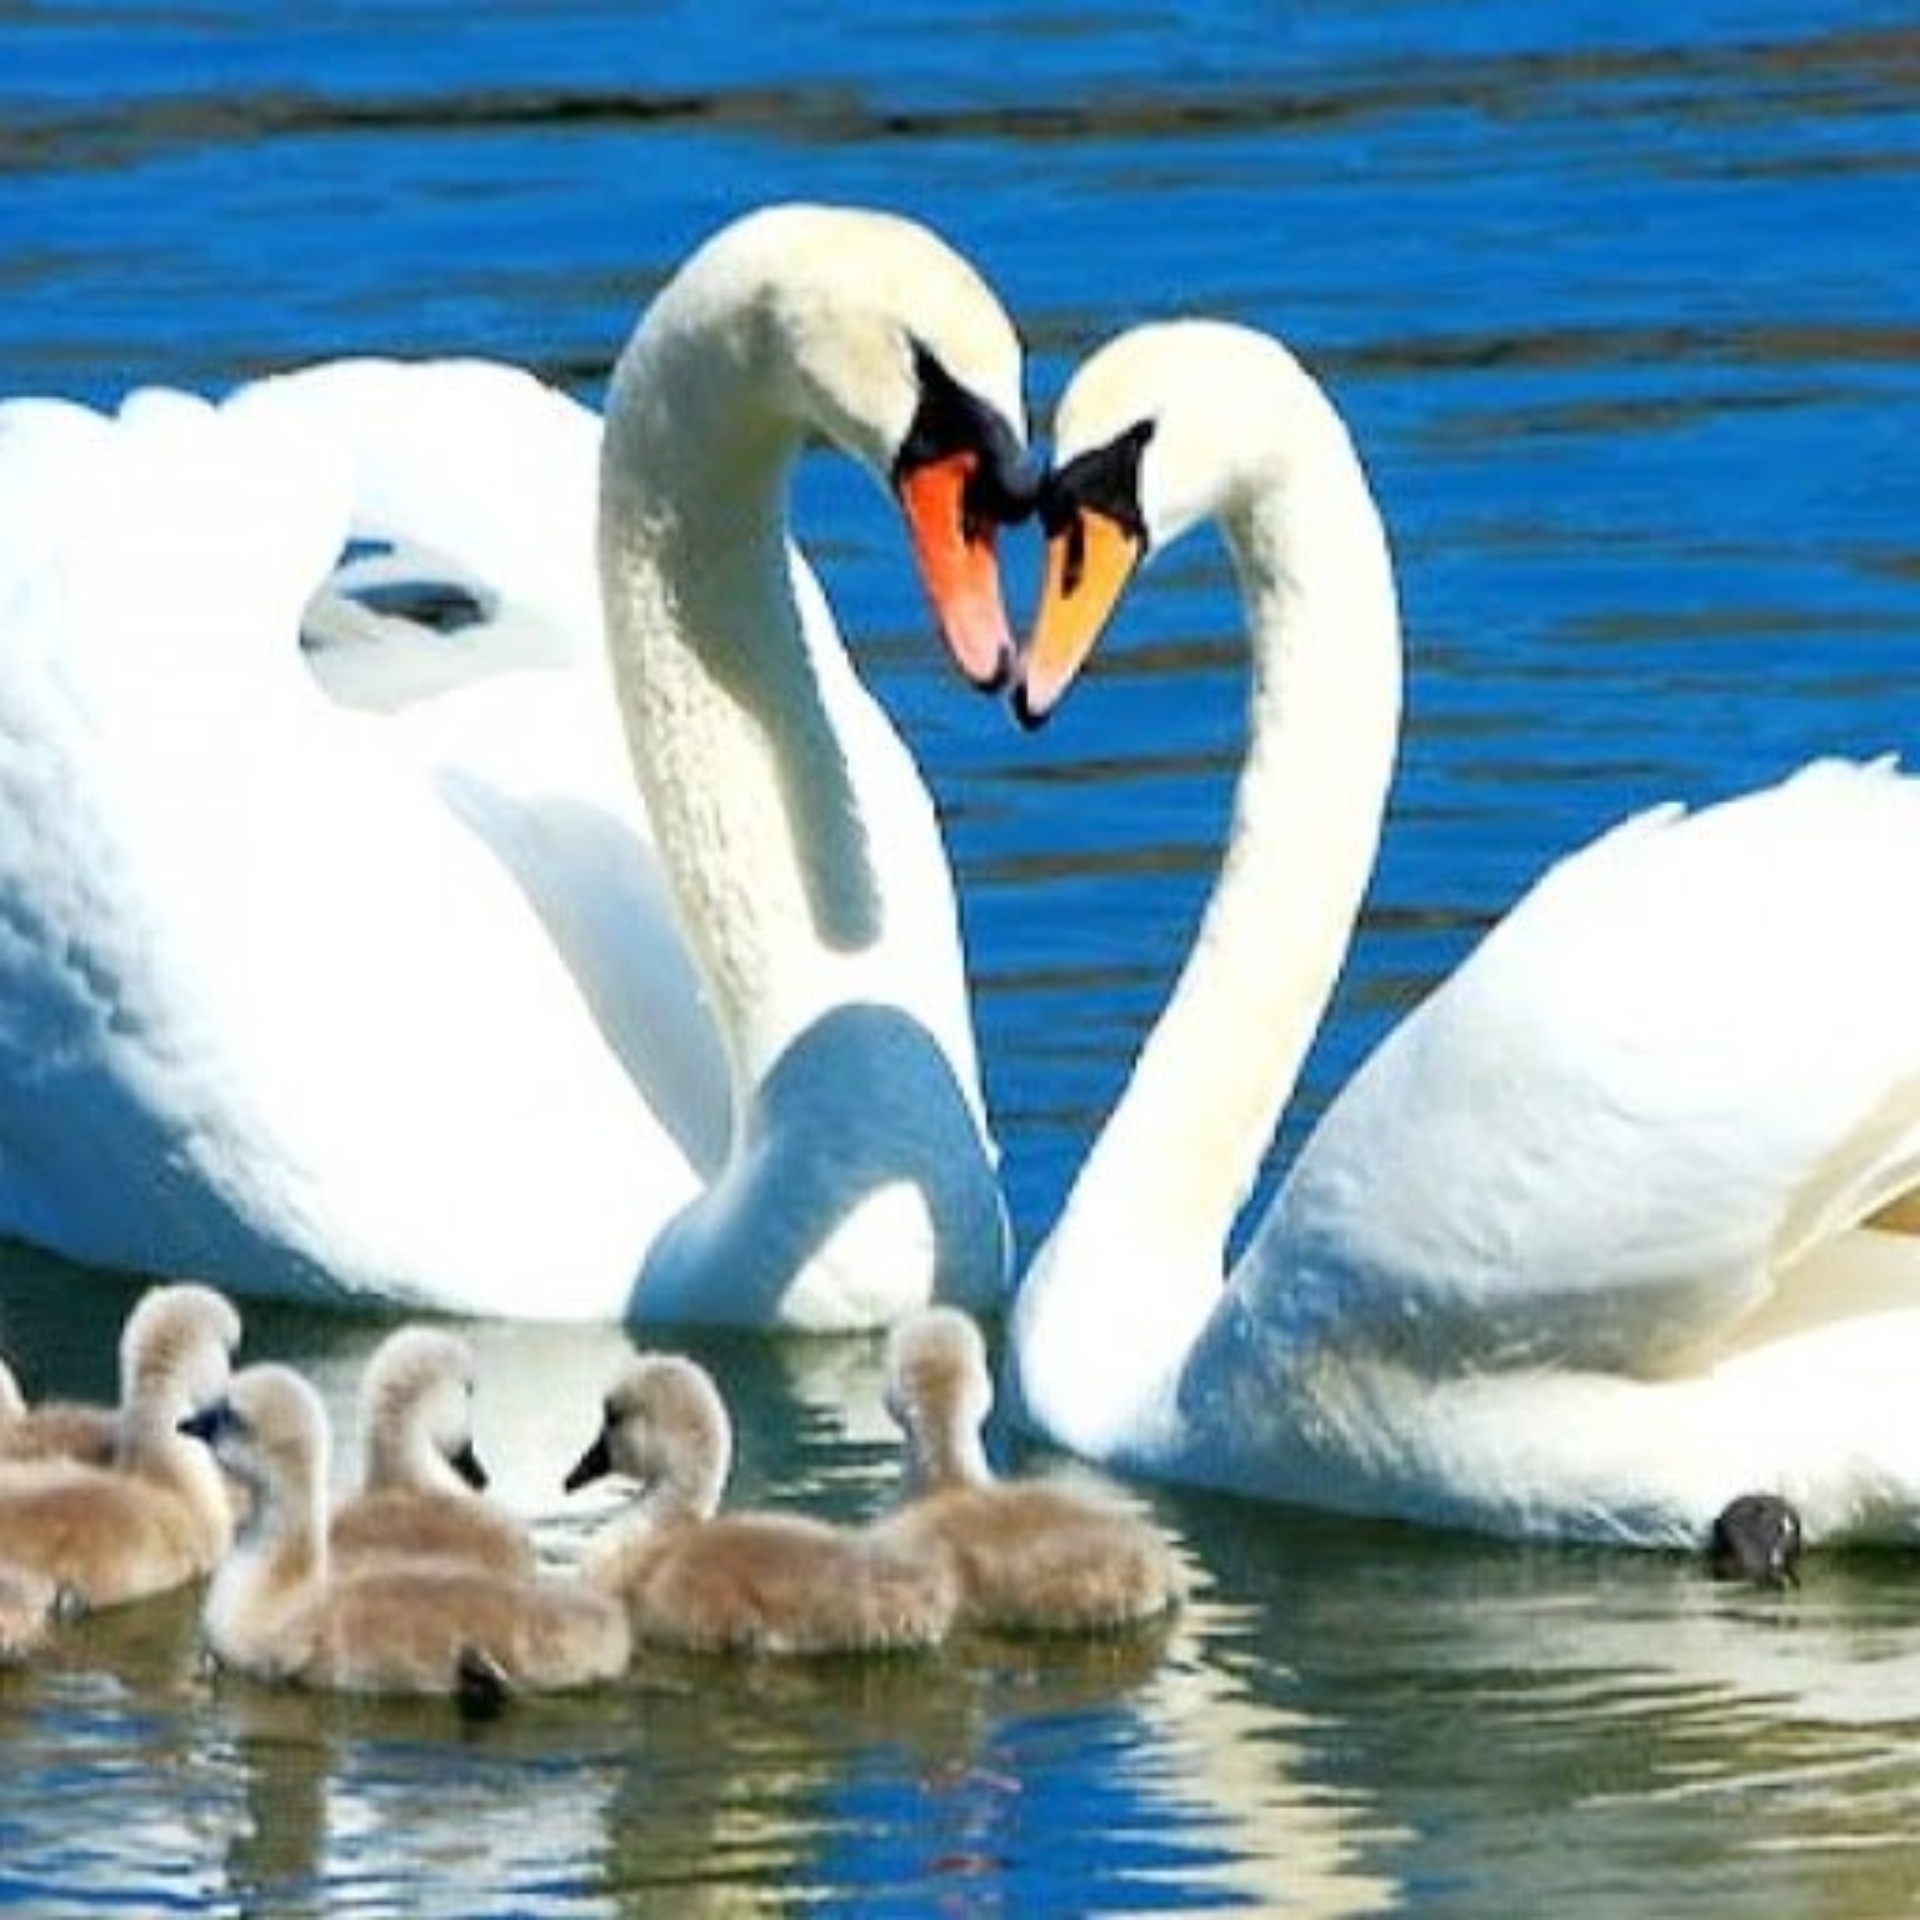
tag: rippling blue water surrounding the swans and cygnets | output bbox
[0,0,1920,1916]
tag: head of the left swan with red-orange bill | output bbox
[625,205,1039,687]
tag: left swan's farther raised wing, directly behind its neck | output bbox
[227,359,732,1173]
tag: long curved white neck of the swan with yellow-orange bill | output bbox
[1018,374,1400,1417]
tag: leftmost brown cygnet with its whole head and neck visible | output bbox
[0,1284,240,1607]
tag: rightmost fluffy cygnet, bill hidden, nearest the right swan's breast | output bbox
[879,1306,1183,1634]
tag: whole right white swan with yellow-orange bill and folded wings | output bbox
[1010,323,1920,1548]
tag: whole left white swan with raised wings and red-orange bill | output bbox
[0,207,1021,1327]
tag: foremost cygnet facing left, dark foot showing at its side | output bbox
[184,1363,630,1697]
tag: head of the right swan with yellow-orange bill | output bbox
[1014,321,1331,726]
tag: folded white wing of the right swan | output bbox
[1238,762,1920,1373]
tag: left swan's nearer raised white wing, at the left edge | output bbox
[0,382,693,1315]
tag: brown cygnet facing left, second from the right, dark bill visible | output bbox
[566,1354,958,1655]
